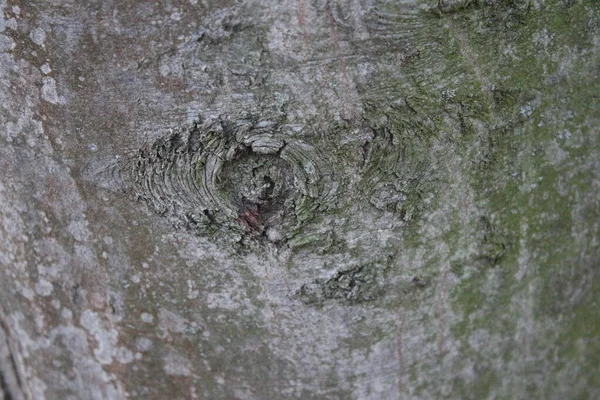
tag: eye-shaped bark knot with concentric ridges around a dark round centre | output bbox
[105,114,337,242]
